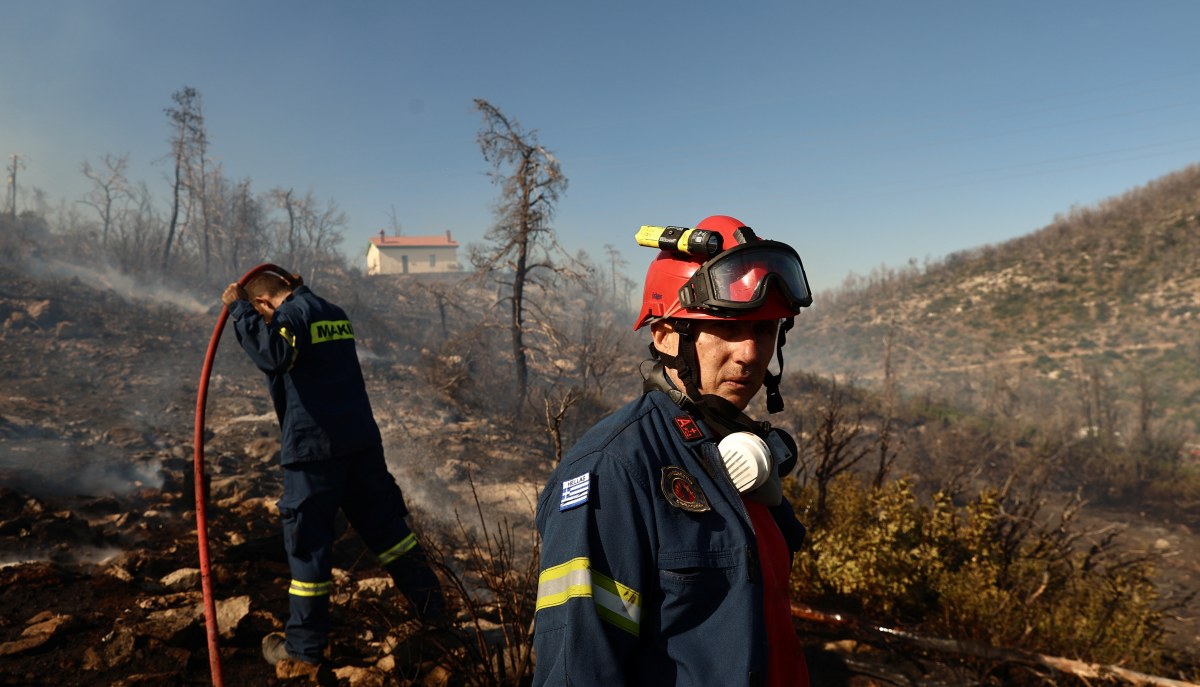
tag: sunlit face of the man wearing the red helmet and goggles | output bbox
[653,319,779,411]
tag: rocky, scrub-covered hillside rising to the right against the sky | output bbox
[793,166,1200,436]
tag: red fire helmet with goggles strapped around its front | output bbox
[634,215,812,329]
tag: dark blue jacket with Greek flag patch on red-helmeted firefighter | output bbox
[534,390,803,687]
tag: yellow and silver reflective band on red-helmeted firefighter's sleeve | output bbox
[536,557,642,637]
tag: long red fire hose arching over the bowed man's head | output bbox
[192,263,290,687]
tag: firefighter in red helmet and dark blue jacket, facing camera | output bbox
[534,215,812,687]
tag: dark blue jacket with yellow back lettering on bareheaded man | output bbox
[229,286,382,465]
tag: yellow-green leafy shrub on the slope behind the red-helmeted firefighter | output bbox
[790,473,1163,670]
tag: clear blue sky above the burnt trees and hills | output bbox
[0,0,1200,297]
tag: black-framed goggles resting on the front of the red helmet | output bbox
[679,240,812,317]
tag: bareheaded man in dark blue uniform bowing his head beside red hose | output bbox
[221,270,446,664]
